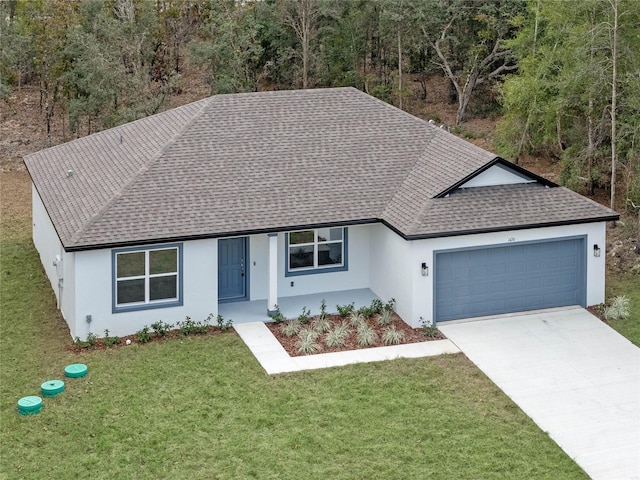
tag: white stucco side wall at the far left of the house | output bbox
[31,185,75,334]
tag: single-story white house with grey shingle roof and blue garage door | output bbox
[25,88,618,338]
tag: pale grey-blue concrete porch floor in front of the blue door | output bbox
[218,288,378,323]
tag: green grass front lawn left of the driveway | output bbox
[0,171,587,479]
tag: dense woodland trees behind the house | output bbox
[0,0,640,218]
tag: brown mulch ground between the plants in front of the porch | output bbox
[266,313,446,357]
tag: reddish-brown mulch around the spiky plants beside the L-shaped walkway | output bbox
[265,313,446,357]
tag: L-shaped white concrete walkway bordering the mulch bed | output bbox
[233,322,460,375]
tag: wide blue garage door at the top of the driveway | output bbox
[434,238,586,321]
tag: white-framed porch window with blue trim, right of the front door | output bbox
[286,227,347,275]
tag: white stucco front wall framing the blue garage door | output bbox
[403,222,606,327]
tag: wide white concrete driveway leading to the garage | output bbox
[438,307,640,480]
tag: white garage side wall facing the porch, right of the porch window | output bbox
[369,224,412,322]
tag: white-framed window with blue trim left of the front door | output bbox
[113,245,182,311]
